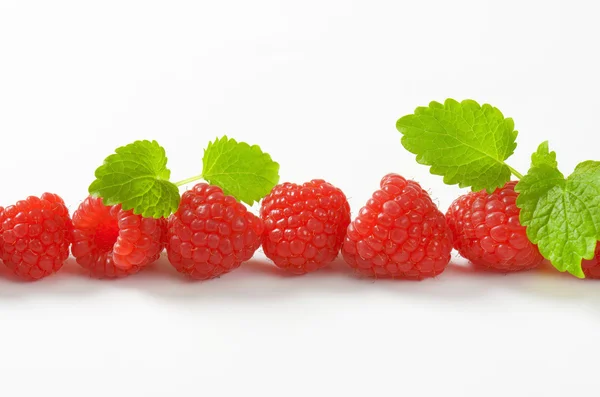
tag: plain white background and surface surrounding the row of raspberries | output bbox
[0,0,600,397]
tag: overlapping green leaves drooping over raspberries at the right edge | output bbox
[515,143,600,278]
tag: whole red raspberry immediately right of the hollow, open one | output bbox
[167,183,264,280]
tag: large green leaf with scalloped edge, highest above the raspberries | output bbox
[396,99,517,192]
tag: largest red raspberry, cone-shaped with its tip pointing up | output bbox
[342,174,452,280]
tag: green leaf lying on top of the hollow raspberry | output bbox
[89,141,179,218]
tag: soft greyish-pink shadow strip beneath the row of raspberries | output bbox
[0,252,600,311]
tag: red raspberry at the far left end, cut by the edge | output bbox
[0,193,72,280]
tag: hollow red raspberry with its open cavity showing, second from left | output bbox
[71,197,167,278]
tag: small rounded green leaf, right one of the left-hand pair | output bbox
[202,136,279,205]
